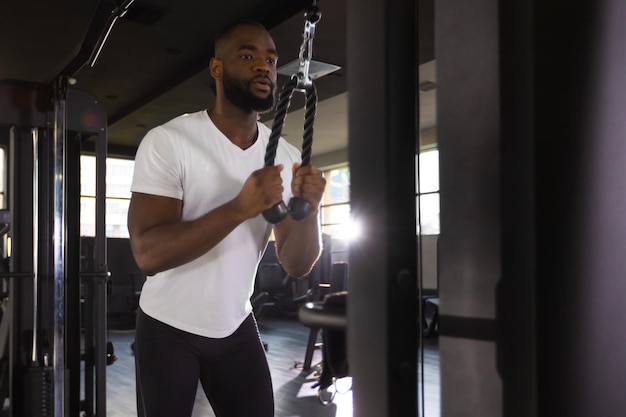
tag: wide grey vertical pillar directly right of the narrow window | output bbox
[435,0,502,417]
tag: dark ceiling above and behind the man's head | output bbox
[0,0,434,158]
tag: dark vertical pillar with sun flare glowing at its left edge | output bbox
[348,0,418,417]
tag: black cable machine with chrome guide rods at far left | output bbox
[0,0,133,417]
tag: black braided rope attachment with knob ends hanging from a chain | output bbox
[263,2,322,224]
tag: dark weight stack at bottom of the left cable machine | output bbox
[22,366,54,417]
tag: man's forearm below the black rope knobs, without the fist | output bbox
[277,214,322,278]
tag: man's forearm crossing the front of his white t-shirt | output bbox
[131,202,246,275]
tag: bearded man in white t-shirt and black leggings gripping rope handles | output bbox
[128,22,325,417]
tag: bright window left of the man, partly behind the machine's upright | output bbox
[80,155,135,237]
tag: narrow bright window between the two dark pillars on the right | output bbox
[415,149,440,235]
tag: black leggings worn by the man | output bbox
[135,310,274,417]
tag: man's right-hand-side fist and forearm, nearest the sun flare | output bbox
[274,164,326,278]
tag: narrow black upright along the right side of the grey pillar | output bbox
[497,1,540,417]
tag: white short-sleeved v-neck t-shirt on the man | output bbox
[131,111,300,338]
